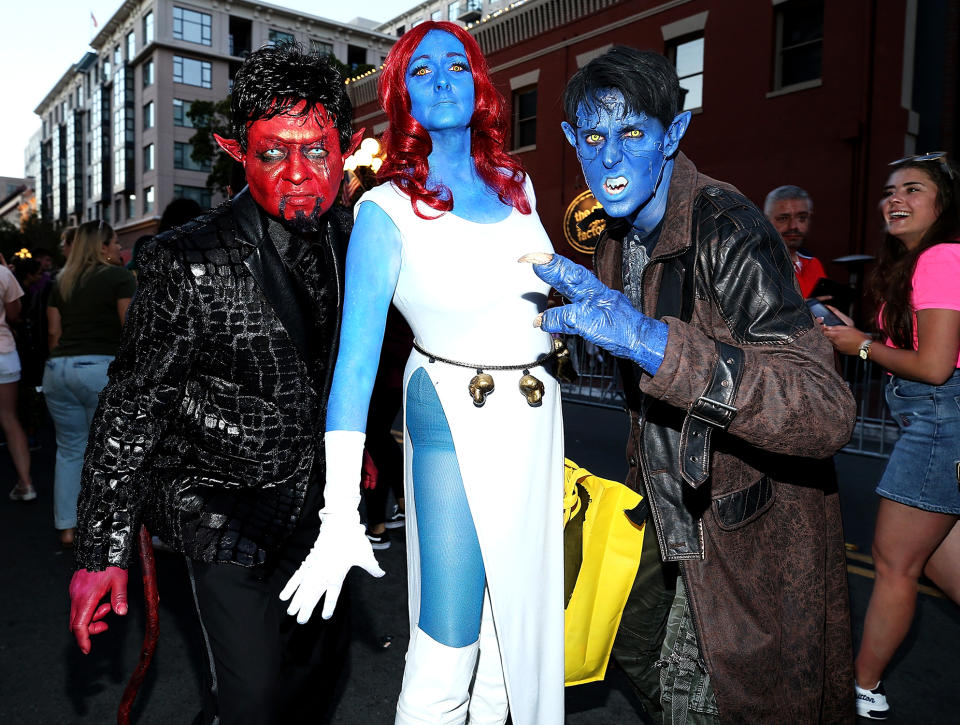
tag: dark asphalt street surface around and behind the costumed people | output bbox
[0,404,960,725]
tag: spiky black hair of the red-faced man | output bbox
[231,43,353,152]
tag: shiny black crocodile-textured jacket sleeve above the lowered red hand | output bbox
[76,244,199,571]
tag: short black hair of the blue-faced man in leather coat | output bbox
[563,45,684,129]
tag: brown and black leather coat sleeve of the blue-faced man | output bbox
[640,219,856,458]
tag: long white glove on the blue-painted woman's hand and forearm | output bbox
[280,430,384,624]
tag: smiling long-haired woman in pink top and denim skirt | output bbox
[823,153,960,719]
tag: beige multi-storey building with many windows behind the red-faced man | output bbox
[36,0,396,247]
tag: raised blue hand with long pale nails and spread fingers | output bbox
[533,254,669,375]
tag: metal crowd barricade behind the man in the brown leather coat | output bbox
[560,335,899,458]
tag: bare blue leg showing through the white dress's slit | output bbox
[407,368,486,647]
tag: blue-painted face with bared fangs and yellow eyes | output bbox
[564,90,667,226]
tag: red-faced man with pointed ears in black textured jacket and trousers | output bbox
[70,45,362,725]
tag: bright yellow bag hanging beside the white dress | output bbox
[563,459,644,686]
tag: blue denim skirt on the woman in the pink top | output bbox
[877,370,960,514]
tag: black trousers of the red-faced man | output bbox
[187,486,350,725]
